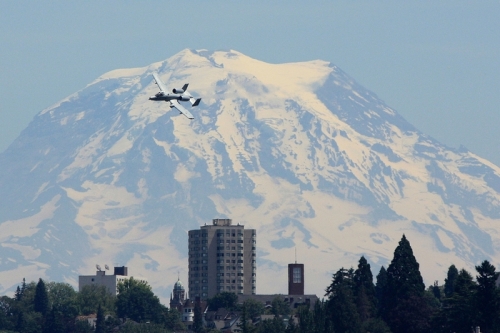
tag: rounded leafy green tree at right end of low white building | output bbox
[116,278,165,323]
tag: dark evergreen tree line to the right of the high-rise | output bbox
[245,235,500,333]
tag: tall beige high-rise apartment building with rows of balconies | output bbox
[189,219,257,300]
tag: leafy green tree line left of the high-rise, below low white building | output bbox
[0,278,184,333]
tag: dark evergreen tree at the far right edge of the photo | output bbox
[476,260,500,333]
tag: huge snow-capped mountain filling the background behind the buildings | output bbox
[0,50,500,300]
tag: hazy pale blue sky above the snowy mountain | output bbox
[0,0,500,165]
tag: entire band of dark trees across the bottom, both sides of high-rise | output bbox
[0,235,500,333]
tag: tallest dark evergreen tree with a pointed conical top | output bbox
[382,235,430,333]
